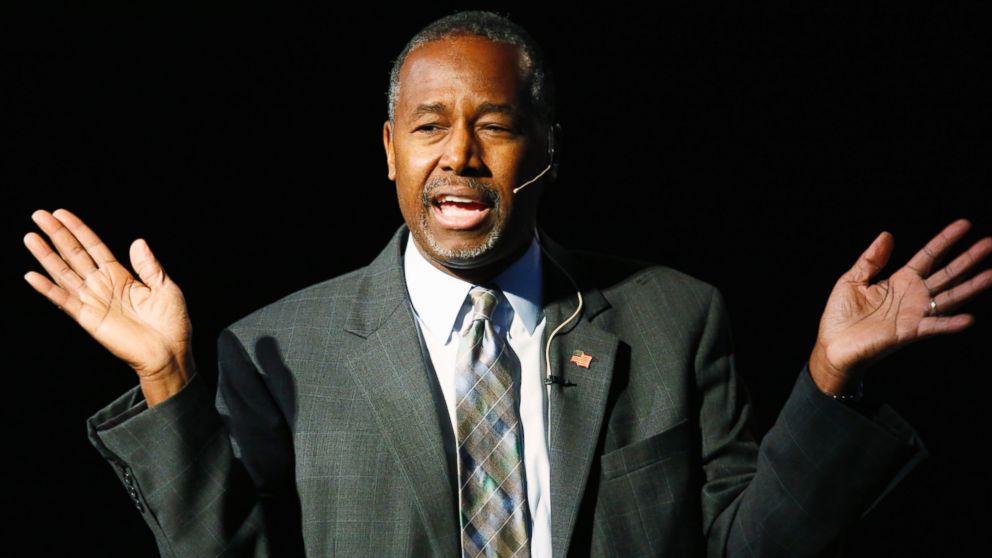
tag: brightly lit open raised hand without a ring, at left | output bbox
[24,209,195,406]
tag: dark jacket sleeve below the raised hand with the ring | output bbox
[695,288,928,558]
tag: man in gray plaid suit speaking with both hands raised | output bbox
[19,8,992,557]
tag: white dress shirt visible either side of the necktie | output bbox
[403,230,551,558]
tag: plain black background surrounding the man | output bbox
[0,2,992,557]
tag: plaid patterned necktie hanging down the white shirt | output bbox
[455,287,530,558]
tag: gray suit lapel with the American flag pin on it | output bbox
[538,229,619,557]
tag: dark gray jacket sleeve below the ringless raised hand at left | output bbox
[87,329,302,558]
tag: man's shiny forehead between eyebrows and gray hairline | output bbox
[397,36,524,117]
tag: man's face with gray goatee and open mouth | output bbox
[383,36,547,276]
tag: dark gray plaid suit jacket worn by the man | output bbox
[87,225,927,558]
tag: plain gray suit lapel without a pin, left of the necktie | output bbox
[345,225,460,556]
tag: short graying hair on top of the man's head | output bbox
[386,10,555,126]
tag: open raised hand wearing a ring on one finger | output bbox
[809,219,992,394]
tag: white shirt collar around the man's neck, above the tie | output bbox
[403,229,542,344]
